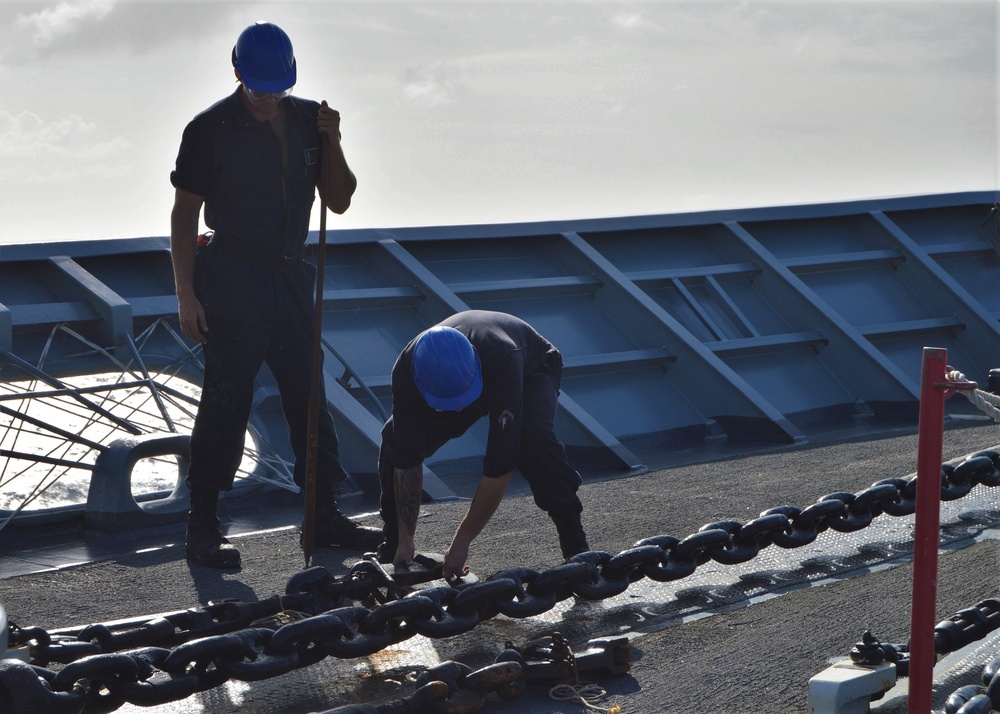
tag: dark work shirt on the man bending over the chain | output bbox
[392,310,558,477]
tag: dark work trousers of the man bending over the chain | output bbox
[378,355,583,541]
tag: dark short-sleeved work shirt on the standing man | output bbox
[170,87,320,254]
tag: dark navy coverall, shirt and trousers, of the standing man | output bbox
[170,88,346,493]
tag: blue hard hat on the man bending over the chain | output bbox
[413,325,483,412]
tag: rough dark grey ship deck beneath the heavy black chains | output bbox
[0,416,1000,714]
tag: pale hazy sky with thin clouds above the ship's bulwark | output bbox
[0,0,1000,245]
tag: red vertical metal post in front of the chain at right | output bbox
[906,347,948,714]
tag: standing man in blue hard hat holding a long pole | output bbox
[170,22,381,567]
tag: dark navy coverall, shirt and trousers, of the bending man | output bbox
[379,310,583,542]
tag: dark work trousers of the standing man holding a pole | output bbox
[187,247,347,497]
